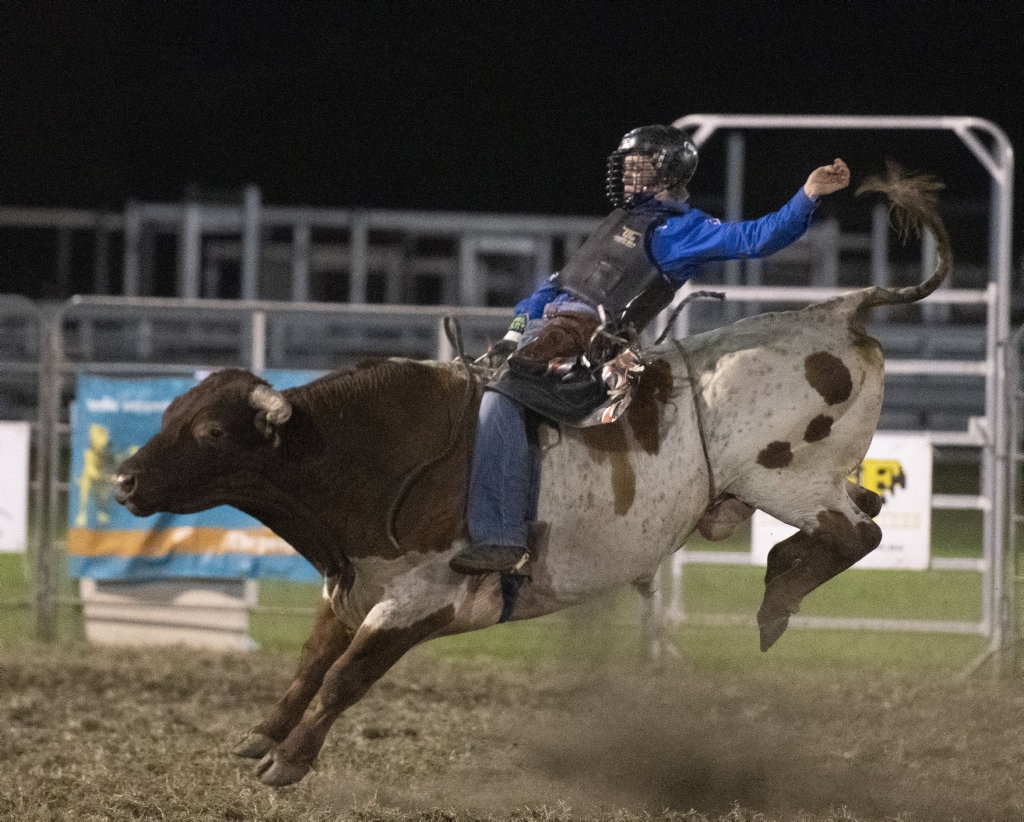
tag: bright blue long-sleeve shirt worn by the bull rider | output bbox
[515,186,817,319]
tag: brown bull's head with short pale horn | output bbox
[116,369,292,516]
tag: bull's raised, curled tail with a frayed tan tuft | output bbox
[857,161,953,310]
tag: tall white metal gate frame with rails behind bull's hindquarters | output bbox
[653,115,1016,665]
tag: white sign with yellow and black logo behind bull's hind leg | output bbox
[751,433,932,570]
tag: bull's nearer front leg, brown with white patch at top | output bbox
[256,600,456,786]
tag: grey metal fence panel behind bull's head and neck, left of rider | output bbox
[33,297,508,640]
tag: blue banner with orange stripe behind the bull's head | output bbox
[68,372,318,581]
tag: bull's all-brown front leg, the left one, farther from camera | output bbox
[234,601,352,760]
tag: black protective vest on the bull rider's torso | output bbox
[554,209,676,332]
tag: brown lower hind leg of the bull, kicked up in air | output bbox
[758,491,882,651]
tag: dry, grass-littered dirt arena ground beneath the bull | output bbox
[0,644,1024,822]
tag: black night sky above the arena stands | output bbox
[0,0,1024,241]
